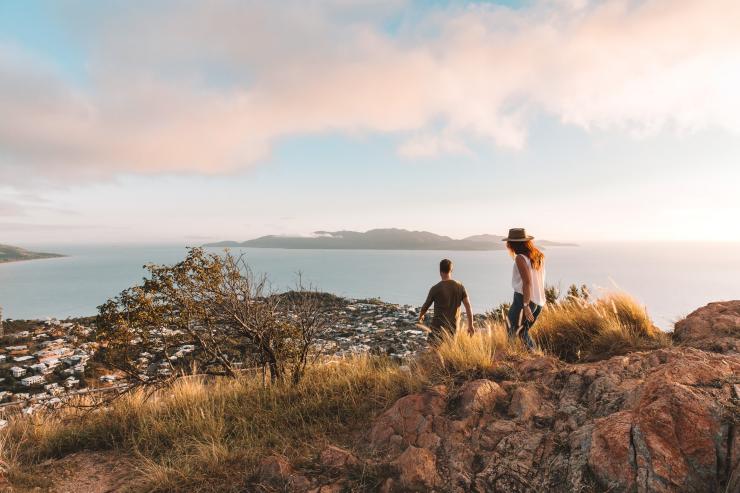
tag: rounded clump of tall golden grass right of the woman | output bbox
[531,293,670,362]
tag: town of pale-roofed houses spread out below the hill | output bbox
[0,298,434,422]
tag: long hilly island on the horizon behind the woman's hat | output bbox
[204,228,576,251]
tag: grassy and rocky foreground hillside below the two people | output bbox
[0,301,740,493]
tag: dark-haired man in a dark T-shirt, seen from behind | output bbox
[419,259,473,344]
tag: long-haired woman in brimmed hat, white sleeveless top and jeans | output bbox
[503,228,545,349]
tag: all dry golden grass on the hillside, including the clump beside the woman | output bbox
[0,286,669,491]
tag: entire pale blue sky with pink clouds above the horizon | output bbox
[0,0,740,245]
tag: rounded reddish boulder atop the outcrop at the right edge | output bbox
[673,300,740,353]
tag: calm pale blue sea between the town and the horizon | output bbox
[0,243,740,330]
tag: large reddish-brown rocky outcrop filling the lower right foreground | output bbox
[256,302,740,492]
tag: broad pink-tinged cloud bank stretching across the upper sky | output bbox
[0,0,740,184]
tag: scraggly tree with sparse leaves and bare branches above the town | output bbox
[97,248,328,385]
